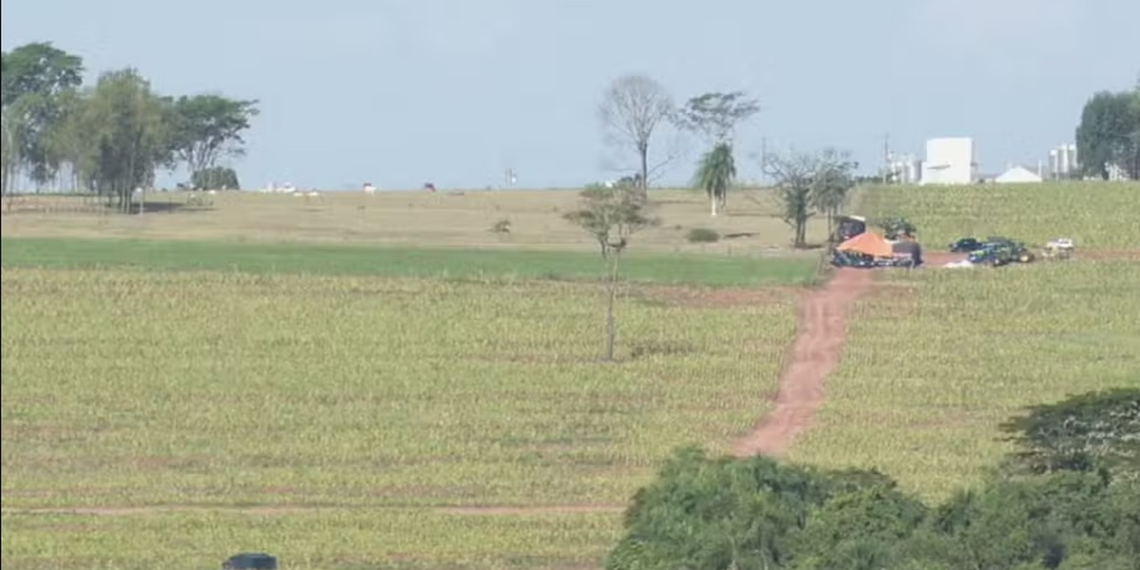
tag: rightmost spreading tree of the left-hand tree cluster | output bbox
[171,95,259,188]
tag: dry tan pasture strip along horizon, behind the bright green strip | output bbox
[0,189,827,255]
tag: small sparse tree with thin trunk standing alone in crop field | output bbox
[565,185,658,360]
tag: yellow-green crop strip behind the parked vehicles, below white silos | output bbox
[861,182,1140,250]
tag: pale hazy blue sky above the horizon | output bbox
[0,0,1140,187]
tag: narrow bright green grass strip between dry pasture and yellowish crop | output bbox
[0,237,819,286]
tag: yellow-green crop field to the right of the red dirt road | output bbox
[791,180,1140,498]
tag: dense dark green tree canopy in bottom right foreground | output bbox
[606,389,1140,570]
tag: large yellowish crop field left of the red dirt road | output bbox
[0,264,797,569]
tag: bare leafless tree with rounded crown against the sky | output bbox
[597,74,675,196]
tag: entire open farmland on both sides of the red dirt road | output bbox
[0,180,1140,570]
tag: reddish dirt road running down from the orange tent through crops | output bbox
[733,269,872,457]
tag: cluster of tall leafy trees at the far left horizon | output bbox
[0,42,258,212]
